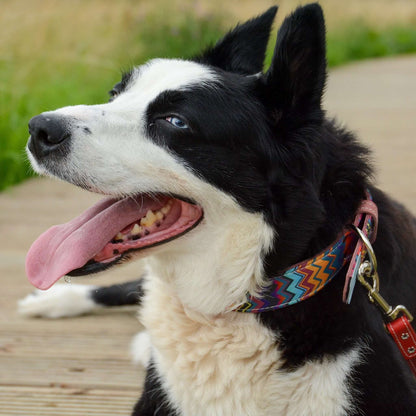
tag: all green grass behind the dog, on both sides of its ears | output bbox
[0,13,416,190]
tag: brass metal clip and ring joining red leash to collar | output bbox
[351,225,413,322]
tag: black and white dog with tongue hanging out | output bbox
[20,4,416,416]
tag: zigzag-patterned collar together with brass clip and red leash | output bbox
[232,192,416,377]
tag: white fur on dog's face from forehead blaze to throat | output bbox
[29,60,274,313]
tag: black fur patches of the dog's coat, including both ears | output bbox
[30,4,416,416]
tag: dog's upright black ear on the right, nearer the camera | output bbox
[262,3,326,117]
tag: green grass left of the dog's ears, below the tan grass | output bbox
[0,15,223,190]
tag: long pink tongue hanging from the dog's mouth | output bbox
[26,197,161,289]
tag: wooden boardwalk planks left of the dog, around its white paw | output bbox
[0,179,143,416]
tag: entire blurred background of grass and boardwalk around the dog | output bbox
[0,0,416,416]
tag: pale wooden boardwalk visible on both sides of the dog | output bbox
[0,56,416,416]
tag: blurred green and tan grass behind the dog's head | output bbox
[0,0,416,190]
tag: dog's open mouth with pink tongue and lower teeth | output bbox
[26,195,203,289]
